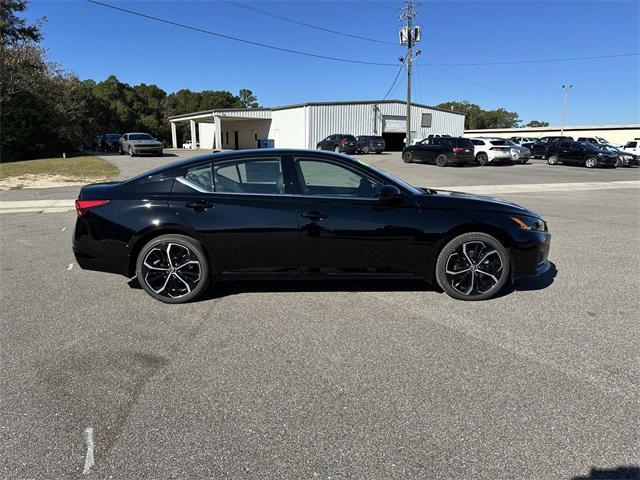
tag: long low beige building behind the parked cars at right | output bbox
[464,125,640,144]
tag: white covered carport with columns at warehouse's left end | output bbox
[169,108,271,150]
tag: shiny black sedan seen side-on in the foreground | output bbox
[73,150,550,303]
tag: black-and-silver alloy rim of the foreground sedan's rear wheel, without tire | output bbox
[142,242,202,299]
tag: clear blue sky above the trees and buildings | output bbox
[26,0,640,125]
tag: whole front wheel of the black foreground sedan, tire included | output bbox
[436,232,509,301]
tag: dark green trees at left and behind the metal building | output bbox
[0,0,548,162]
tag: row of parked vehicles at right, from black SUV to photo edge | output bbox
[402,135,640,168]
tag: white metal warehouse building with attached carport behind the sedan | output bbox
[169,100,464,150]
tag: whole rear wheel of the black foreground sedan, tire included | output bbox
[136,234,211,303]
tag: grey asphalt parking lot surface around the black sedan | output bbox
[0,150,640,479]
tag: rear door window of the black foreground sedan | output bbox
[213,157,285,195]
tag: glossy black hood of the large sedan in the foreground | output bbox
[423,189,541,218]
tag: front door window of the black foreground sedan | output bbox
[294,158,382,198]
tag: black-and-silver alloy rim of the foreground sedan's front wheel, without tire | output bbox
[445,240,504,297]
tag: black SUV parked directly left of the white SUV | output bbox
[402,137,476,167]
